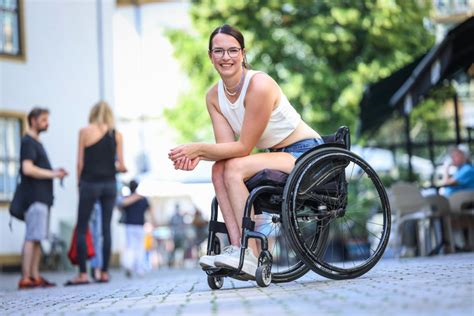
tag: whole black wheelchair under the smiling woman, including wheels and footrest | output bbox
[203,126,391,289]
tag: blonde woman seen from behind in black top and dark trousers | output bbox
[66,101,127,285]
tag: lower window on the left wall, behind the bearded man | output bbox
[0,112,26,203]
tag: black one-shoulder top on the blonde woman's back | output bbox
[81,130,117,182]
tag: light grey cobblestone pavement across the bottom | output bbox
[0,253,474,316]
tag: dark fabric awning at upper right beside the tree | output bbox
[359,17,474,135]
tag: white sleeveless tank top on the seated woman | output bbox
[217,70,301,149]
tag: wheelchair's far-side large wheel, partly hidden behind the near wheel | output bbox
[254,211,309,283]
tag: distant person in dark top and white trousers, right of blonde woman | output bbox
[120,180,150,277]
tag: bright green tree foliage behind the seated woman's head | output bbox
[165,0,433,140]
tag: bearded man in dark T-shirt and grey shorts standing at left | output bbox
[18,107,68,289]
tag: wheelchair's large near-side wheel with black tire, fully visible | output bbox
[282,147,391,279]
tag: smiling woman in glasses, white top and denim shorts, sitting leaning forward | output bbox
[169,25,323,277]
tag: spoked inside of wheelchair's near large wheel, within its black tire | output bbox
[291,154,390,273]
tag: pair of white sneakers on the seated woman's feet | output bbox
[214,246,258,278]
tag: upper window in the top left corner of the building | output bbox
[0,0,25,60]
